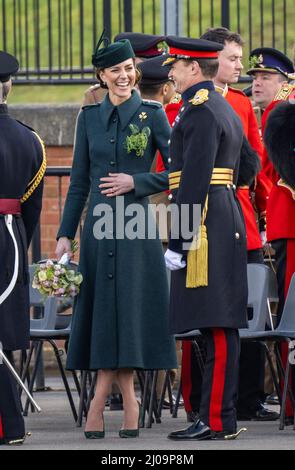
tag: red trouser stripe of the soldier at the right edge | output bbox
[281,239,295,416]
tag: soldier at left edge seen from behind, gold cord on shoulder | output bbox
[0,51,46,444]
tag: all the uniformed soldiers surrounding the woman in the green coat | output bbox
[0,27,295,444]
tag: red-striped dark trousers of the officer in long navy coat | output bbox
[200,328,240,432]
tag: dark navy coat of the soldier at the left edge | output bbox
[0,104,43,351]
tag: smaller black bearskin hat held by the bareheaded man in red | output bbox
[237,136,261,186]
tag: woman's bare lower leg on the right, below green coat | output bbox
[117,369,139,429]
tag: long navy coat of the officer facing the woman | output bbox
[169,81,247,333]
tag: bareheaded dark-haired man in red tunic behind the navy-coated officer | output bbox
[178,27,279,421]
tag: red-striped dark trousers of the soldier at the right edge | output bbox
[271,239,295,417]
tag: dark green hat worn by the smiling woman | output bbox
[92,32,135,69]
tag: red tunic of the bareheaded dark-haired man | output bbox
[223,87,272,250]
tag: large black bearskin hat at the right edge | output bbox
[264,102,295,187]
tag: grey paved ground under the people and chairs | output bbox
[1,379,295,453]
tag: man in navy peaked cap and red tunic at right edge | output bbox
[251,47,295,424]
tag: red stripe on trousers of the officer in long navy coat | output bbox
[209,328,227,432]
